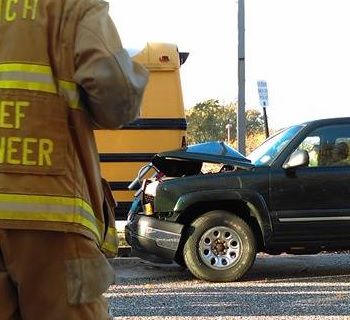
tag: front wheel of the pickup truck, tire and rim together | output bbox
[184,210,256,282]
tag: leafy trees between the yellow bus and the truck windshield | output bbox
[186,100,264,144]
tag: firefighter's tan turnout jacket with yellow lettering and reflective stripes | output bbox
[0,0,147,256]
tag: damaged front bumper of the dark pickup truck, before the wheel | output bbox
[125,214,183,262]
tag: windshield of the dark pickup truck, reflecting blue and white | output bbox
[247,125,303,166]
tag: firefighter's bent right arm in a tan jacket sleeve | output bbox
[74,3,148,129]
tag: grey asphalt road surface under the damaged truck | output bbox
[106,254,350,320]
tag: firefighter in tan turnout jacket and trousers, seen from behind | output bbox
[0,0,148,320]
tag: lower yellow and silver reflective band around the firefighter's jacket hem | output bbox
[0,194,102,243]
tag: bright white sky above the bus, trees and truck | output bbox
[108,0,350,129]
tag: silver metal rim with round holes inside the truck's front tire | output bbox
[199,226,242,270]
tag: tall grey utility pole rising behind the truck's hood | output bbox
[237,0,246,155]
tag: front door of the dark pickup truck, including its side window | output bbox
[270,124,350,241]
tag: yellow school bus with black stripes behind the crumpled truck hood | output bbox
[95,43,188,220]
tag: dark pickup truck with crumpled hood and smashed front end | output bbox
[126,118,350,281]
